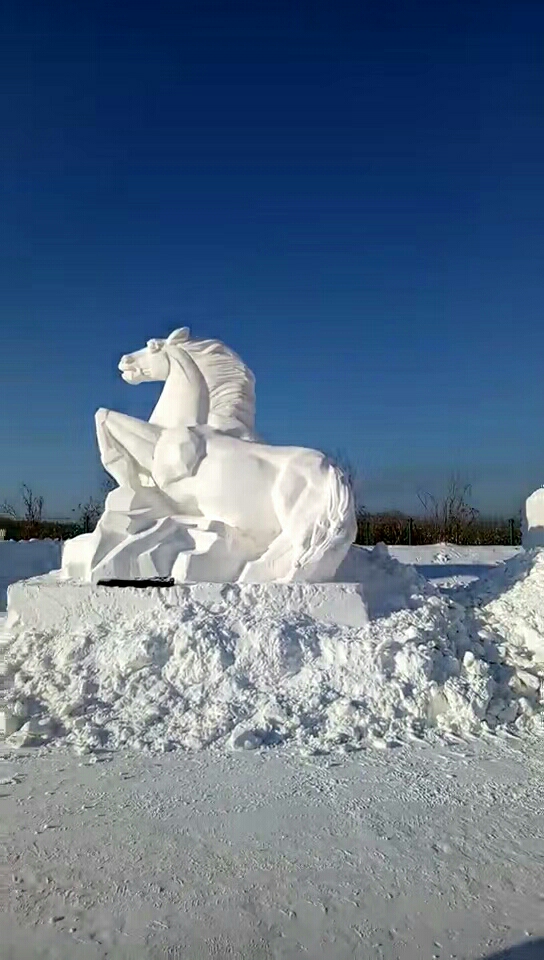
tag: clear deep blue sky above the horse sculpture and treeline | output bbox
[0,0,544,515]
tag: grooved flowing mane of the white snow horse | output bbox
[176,339,255,440]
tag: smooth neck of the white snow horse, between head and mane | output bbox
[149,350,209,428]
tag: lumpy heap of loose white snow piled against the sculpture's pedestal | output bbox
[5,548,543,752]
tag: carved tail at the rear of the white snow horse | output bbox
[294,460,357,580]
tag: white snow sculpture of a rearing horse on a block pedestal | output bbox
[63,327,356,582]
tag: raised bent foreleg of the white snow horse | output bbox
[95,407,161,487]
